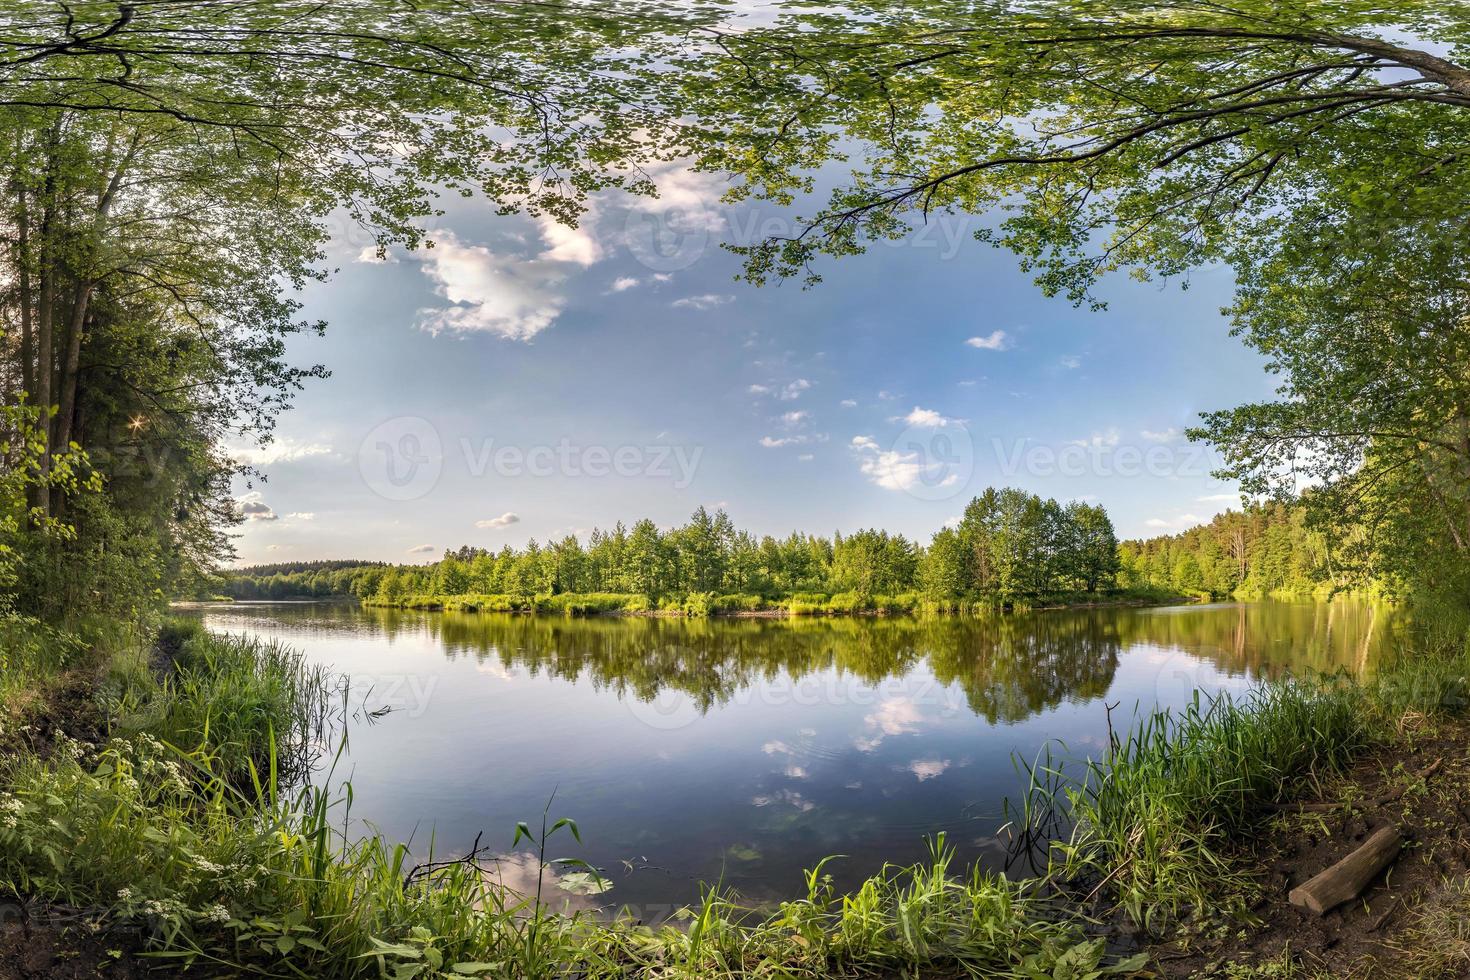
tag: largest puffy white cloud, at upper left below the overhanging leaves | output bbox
[416,234,566,341]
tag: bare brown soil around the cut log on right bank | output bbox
[1151,718,1470,980]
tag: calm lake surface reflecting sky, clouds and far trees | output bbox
[192,602,1391,918]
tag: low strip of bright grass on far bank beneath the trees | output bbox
[362,588,1195,617]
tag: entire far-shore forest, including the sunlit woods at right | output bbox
[219,489,1364,608]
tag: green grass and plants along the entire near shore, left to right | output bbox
[0,608,1470,977]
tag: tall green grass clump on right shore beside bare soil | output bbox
[1025,617,1470,932]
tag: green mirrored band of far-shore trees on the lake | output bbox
[246,602,1388,724]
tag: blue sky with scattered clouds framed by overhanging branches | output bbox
[226,167,1270,563]
